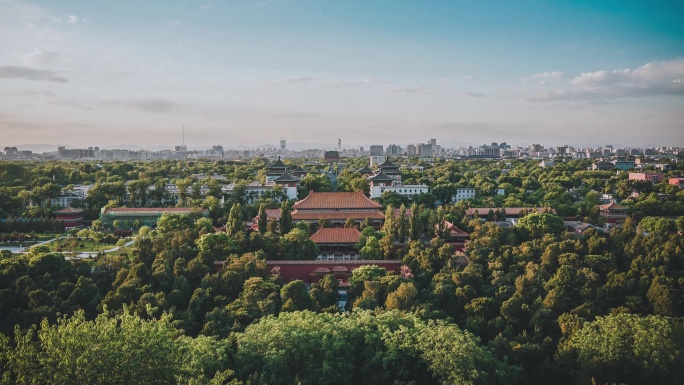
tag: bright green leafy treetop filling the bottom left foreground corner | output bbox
[3,311,235,384]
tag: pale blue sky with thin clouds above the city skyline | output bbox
[0,0,684,148]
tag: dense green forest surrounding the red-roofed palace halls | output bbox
[0,158,684,385]
